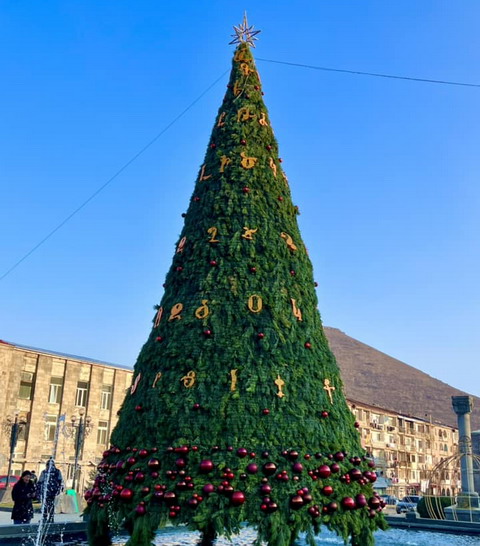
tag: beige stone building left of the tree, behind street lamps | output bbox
[0,342,133,491]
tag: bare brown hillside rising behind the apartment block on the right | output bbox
[325,327,480,430]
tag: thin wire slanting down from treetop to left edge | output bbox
[0,69,230,281]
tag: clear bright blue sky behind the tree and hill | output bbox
[0,0,480,398]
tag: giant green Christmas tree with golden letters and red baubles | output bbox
[85,19,385,546]
